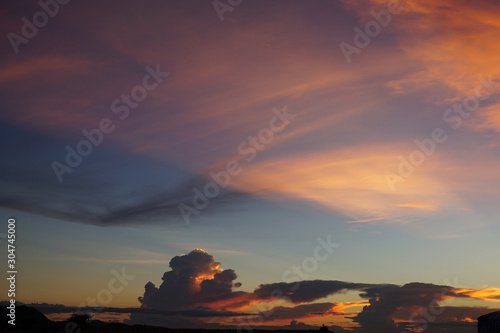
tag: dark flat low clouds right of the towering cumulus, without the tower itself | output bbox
[254,280,488,333]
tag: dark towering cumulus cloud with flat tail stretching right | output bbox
[139,260,376,309]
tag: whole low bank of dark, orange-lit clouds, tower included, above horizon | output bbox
[131,249,496,333]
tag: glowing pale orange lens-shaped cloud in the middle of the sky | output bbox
[213,146,454,222]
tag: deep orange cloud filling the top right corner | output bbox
[345,0,500,130]
